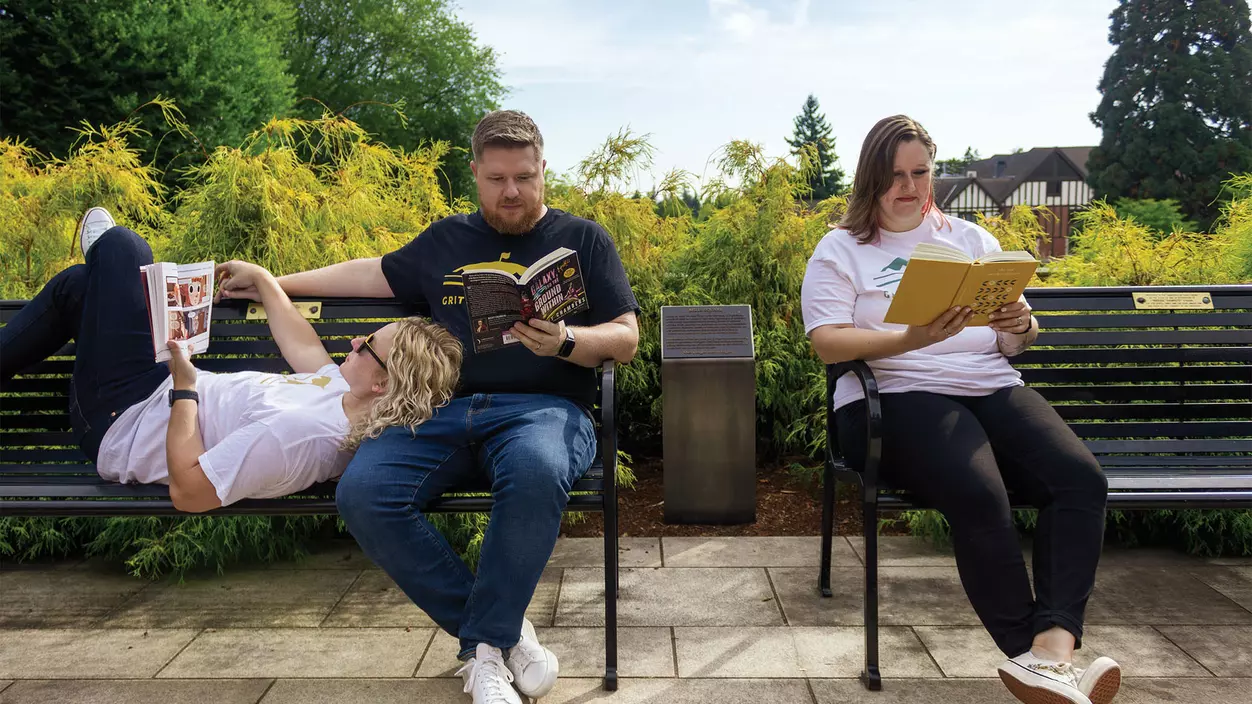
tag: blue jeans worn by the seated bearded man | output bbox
[336,393,596,659]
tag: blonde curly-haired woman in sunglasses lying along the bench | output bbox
[0,208,461,512]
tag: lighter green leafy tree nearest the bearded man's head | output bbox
[284,0,506,195]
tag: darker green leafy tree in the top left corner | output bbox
[0,0,293,174]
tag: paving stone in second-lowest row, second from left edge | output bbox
[159,629,434,678]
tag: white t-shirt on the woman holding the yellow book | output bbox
[801,214,1022,408]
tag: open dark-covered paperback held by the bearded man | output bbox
[461,247,588,353]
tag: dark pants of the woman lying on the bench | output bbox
[0,227,169,461]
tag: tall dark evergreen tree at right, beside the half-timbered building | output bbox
[1088,0,1252,227]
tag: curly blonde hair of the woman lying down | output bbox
[342,317,462,451]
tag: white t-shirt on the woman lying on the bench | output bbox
[96,365,351,506]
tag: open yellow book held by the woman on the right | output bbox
[885,243,1039,326]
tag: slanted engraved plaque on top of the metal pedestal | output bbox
[661,306,755,360]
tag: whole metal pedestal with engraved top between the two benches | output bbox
[661,306,756,524]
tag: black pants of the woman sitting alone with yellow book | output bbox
[835,386,1108,658]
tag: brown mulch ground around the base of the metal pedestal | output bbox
[561,457,901,537]
